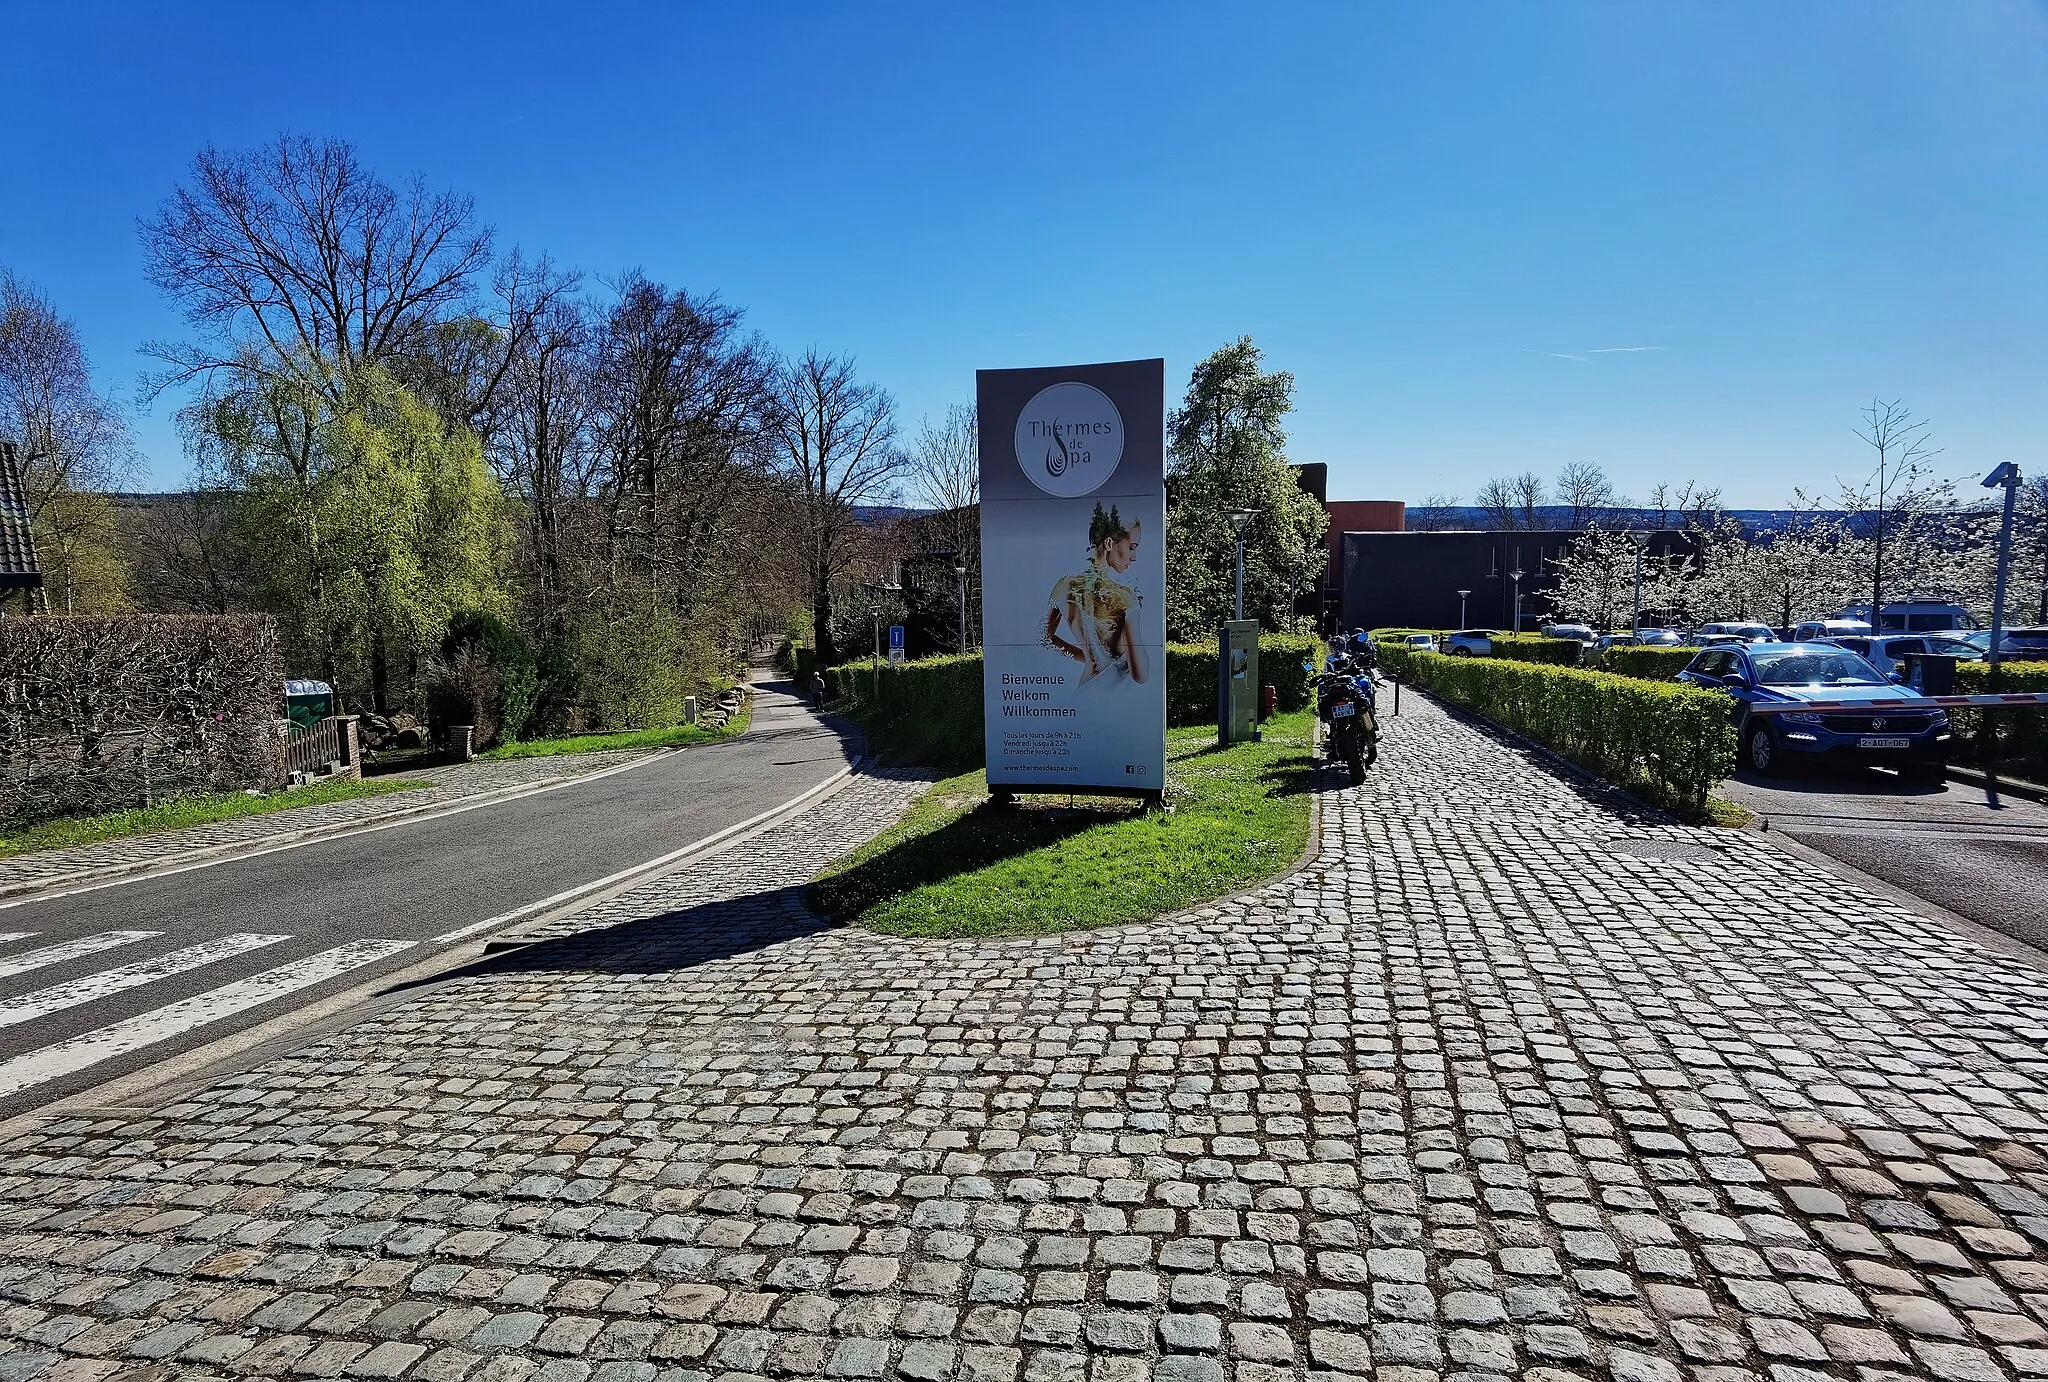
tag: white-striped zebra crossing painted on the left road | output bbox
[0,930,422,1099]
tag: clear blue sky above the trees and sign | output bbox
[0,0,2048,506]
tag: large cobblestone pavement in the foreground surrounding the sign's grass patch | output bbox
[0,696,2048,1382]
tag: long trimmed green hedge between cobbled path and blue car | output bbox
[1403,653,1735,819]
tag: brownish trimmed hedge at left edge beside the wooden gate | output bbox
[0,614,285,821]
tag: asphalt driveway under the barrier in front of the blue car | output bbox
[1726,768,2048,950]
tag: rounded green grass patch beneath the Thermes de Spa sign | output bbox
[809,710,1309,938]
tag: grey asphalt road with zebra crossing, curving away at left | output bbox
[0,686,856,1118]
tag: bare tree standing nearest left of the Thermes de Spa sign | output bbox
[774,348,907,661]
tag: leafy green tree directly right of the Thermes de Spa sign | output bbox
[1165,336,1329,639]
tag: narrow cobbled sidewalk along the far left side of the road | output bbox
[0,749,647,891]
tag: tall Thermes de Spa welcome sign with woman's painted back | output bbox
[975,360,1165,792]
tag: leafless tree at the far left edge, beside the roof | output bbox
[0,268,135,614]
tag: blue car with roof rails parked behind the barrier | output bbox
[1677,643,1952,782]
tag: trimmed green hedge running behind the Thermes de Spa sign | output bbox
[823,633,1323,772]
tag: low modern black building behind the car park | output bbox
[1341,530,1692,631]
